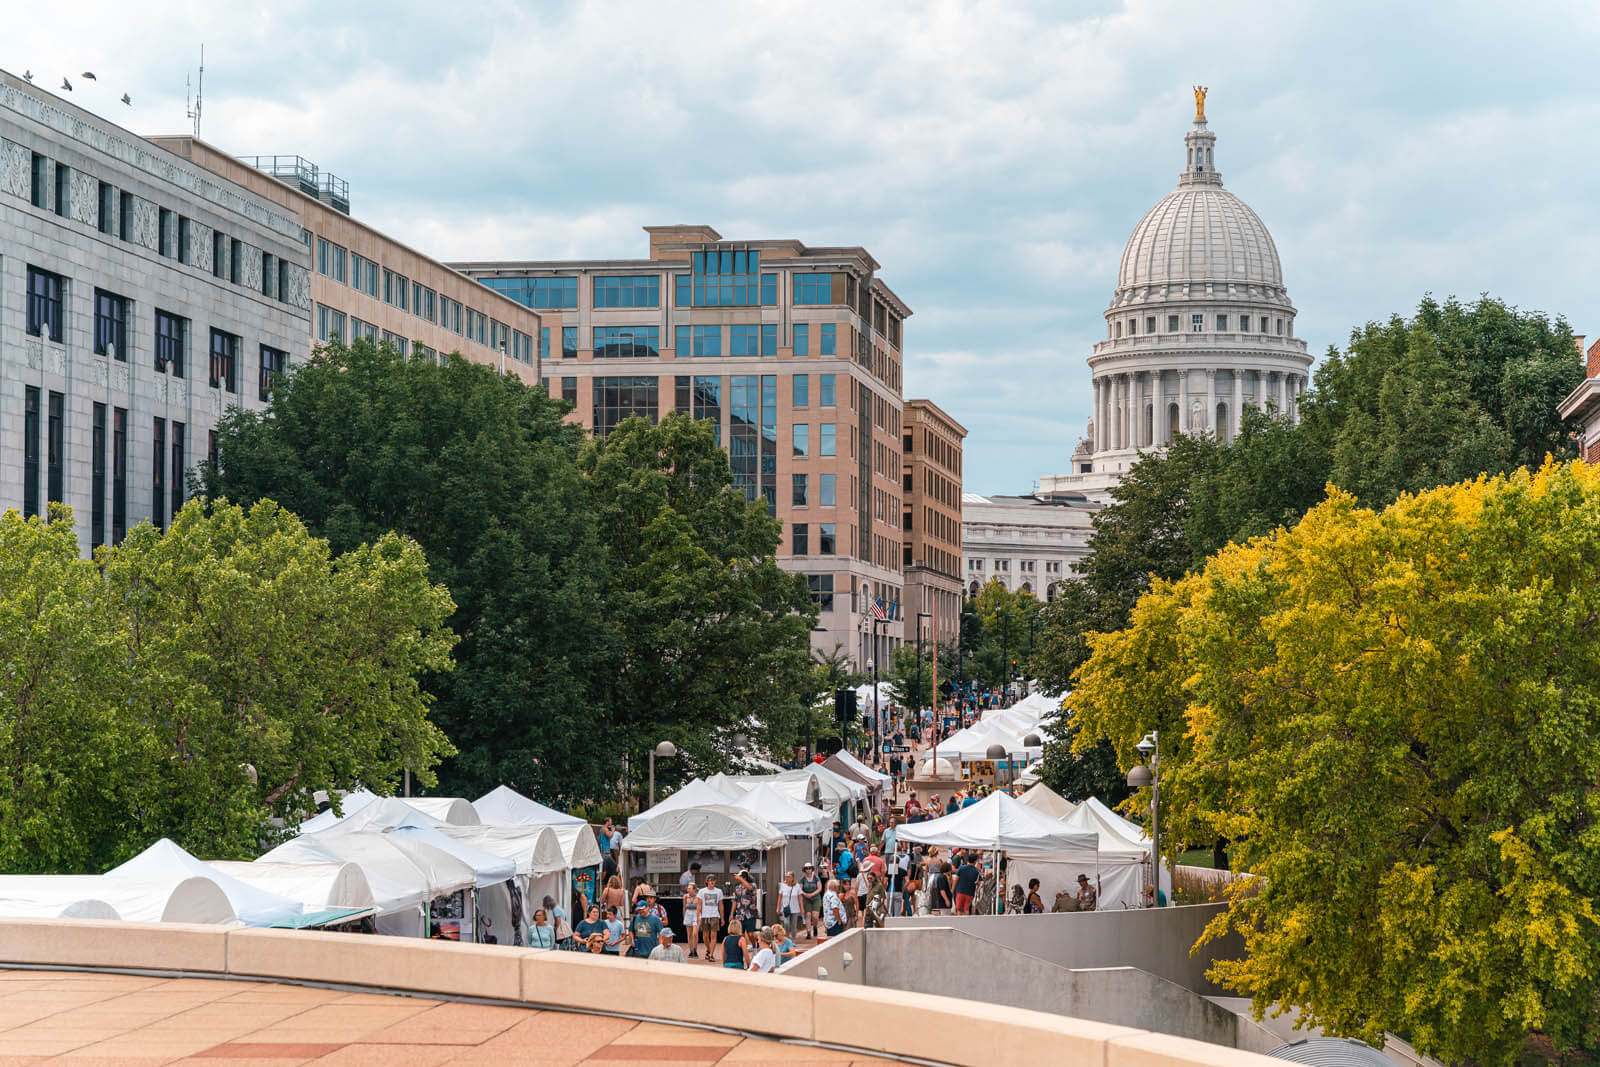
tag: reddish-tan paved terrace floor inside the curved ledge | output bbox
[0,971,893,1067]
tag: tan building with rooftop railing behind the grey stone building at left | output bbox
[154,136,539,384]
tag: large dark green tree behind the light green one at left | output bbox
[202,341,601,801]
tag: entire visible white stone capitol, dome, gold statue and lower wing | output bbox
[962,86,1310,600]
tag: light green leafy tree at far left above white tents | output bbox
[0,501,454,873]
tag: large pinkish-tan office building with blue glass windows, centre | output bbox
[453,226,910,667]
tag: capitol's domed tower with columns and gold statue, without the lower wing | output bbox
[1040,88,1310,499]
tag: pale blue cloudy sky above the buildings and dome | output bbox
[0,0,1600,493]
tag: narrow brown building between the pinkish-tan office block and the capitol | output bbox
[901,400,966,643]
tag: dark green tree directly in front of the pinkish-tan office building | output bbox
[579,414,816,793]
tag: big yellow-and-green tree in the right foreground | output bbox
[1074,462,1600,1064]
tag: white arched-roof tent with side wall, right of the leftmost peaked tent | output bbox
[261,830,477,937]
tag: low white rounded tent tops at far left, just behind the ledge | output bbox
[0,875,238,923]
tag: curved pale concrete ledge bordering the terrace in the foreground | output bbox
[0,920,1280,1067]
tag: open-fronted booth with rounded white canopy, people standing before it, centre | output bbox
[622,803,789,934]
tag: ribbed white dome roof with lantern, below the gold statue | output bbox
[1117,115,1283,291]
